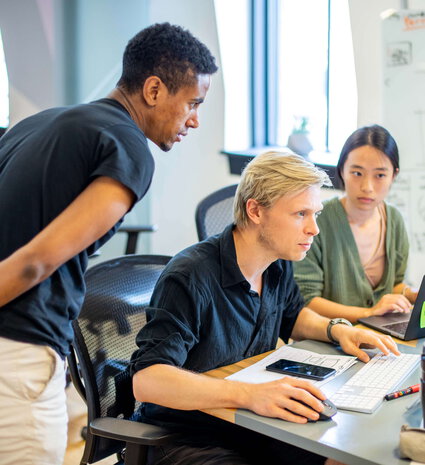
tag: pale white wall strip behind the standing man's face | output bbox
[149,0,239,255]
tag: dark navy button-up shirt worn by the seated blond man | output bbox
[130,225,304,432]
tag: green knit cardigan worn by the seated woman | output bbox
[294,198,409,307]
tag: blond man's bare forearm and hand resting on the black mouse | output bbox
[133,364,325,423]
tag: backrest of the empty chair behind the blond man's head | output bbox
[195,184,237,241]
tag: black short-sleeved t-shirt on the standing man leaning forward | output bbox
[0,99,154,356]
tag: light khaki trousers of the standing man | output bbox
[0,337,68,465]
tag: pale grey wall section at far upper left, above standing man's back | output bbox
[0,0,62,126]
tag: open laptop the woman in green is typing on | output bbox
[358,276,425,341]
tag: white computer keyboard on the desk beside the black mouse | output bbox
[330,354,420,413]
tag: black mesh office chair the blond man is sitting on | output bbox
[68,255,175,465]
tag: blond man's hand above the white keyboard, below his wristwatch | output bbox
[332,325,400,362]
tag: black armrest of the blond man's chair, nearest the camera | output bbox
[90,417,177,446]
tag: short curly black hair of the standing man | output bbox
[117,23,218,94]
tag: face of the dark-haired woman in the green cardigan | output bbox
[342,145,397,210]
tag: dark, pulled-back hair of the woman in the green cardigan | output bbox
[336,124,400,186]
